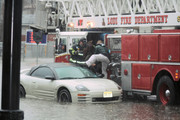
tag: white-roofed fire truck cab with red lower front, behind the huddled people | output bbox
[54,29,107,63]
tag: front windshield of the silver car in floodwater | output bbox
[55,66,97,79]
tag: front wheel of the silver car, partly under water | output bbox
[58,89,72,103]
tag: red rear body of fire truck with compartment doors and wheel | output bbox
[121,32,180,105]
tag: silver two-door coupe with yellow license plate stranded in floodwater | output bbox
[20,63,121,103]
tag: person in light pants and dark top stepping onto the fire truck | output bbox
[84,40,110,78]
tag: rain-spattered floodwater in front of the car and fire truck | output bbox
[20,98,180,120]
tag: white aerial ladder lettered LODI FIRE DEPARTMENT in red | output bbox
[34,0,180,30]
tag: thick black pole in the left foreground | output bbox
[0,0,24,120]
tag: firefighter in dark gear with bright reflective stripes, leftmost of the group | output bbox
[69,38,86,63]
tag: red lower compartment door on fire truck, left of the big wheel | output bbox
[132,64,151,90]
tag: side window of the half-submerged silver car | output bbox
[31,67,54,78]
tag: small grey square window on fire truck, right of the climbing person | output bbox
[110,38,121,51]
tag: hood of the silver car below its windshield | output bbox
[57,78,119,91]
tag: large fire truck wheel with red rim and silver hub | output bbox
[157,76,175,105]
